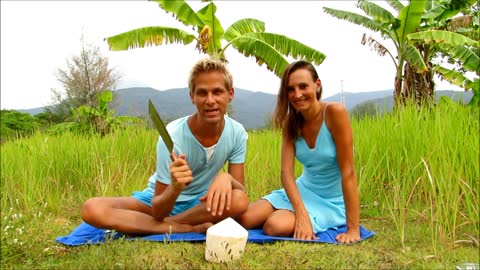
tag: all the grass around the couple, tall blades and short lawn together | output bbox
[0,102,480,269]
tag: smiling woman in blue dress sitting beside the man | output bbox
[239,61,360,243]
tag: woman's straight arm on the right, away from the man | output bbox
[325,103,360,243]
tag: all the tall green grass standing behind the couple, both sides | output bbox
[1,103,480,254]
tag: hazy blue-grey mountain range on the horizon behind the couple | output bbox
[18,87,473,129]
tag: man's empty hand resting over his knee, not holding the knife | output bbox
[200,173,234,216]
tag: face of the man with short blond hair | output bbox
[190,71,233,124]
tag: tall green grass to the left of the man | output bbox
[1,129,158,210]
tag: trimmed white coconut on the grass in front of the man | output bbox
[205,218,248,263]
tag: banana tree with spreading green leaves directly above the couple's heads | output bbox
[106,0,325,76]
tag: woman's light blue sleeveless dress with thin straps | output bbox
[263,117,346,233]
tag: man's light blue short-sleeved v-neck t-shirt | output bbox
[144,116,247,202]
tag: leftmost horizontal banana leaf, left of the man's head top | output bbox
[106,26,195,51]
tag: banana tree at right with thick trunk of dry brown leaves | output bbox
[324,0,474,106]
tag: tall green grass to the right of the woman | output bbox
[353,104,480,252]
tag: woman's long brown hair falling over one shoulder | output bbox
[273,60,322,139]
